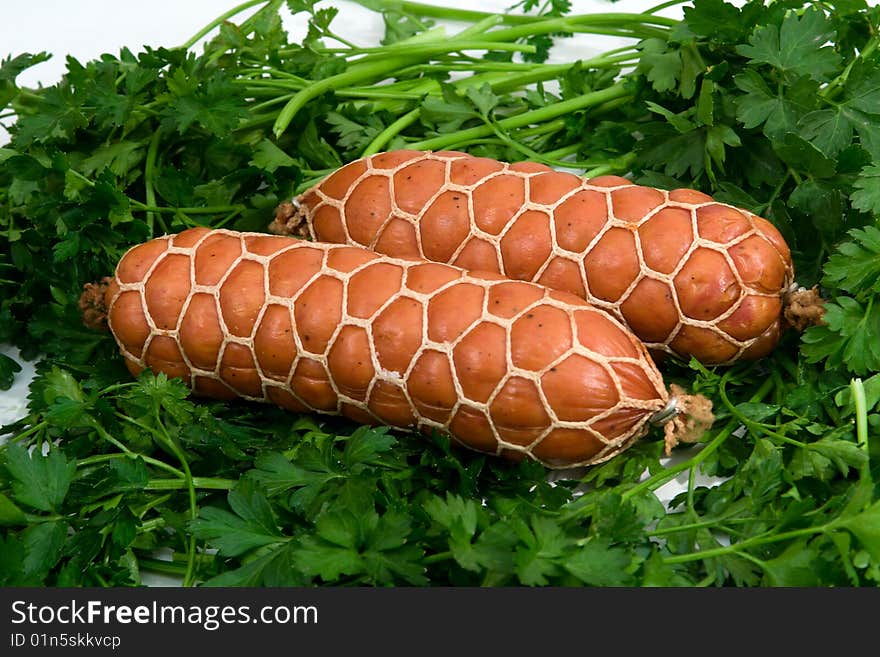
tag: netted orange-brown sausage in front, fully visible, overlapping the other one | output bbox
[93,228,708,468]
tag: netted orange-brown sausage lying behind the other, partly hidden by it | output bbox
[284,150,794,364]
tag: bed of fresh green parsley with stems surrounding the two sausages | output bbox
[0,0,880,586]
